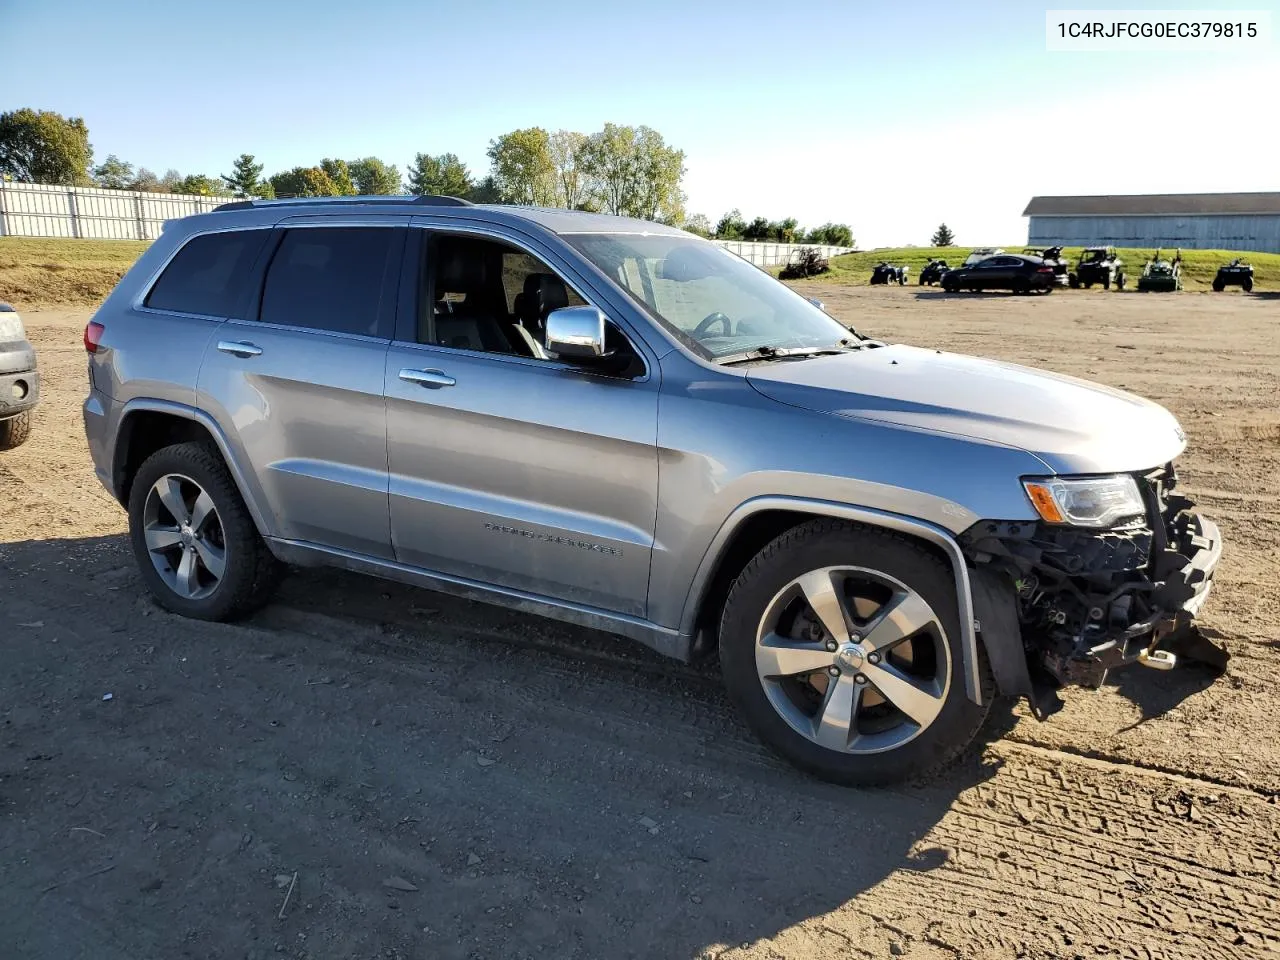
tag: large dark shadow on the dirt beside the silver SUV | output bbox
[0,536,1014,957]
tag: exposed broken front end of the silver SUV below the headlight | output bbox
[960,463,1226,719]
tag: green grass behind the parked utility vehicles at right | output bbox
[788,243,1280,291]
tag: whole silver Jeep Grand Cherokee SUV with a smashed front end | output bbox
[84,197,1221,783]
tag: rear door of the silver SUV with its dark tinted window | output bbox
[197,216,408,558]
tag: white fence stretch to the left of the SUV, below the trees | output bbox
[0,180,232,241]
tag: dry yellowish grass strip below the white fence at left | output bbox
[0,237,150,310]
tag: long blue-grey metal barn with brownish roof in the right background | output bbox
[1023,193,1280,253]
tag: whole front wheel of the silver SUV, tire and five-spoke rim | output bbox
[719,520,992,785]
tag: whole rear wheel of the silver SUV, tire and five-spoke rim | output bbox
[129,443,282,621]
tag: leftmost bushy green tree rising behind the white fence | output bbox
[0,108,93,186]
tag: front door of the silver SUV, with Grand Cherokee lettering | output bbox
[385,229,658,616]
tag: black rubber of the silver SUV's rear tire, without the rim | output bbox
[129,443,284,621]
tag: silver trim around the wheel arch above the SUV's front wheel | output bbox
[680,497,983,707]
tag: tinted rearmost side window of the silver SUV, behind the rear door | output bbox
[146,230,268,316]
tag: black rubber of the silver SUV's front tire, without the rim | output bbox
[719,518,995,786]
